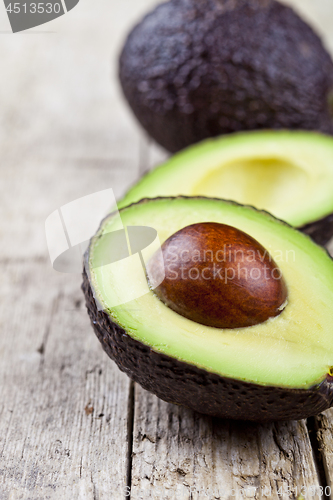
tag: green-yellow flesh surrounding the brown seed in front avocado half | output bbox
[88,197,333,389]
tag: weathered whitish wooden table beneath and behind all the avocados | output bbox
[0,0,333,500]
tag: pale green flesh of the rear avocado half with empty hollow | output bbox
[118,131,333,227]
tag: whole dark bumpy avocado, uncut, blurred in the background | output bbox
[119,0,333,152]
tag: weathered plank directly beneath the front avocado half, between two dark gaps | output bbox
[131,386,321,500]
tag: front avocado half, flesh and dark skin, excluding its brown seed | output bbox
[82,197,333,422]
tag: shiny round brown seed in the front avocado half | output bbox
[147,222,287,328]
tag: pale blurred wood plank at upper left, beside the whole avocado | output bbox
[0,0,163,258]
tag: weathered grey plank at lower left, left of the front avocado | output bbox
[0,262,130,500]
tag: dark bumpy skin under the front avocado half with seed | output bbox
[82,271,333,422]
